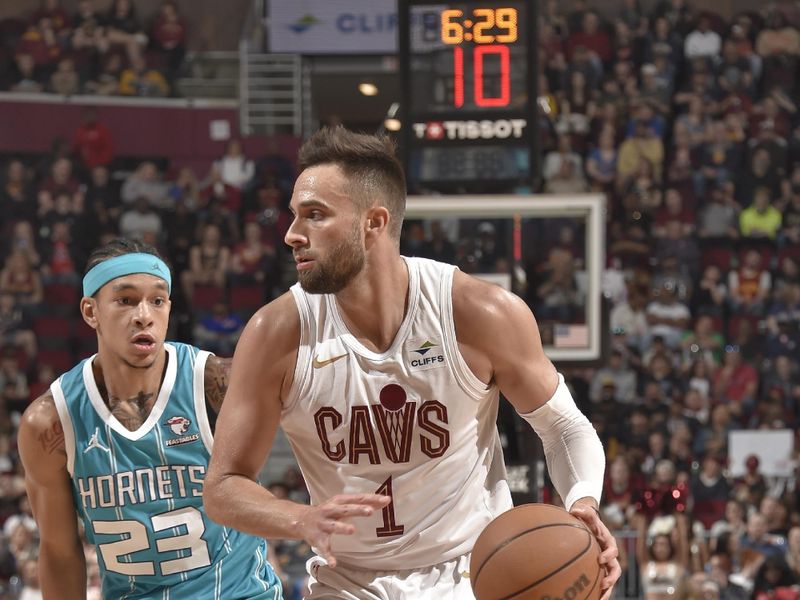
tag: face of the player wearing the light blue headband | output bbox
[84,273,171,369]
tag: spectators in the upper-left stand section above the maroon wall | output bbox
[0,0,187,97]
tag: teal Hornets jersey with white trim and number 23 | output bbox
[50,343,282,600]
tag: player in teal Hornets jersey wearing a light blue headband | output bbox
[19,240,282,600]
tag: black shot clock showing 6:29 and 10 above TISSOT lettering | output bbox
[399,0,537,193]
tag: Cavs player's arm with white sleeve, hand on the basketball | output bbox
[453,271,622,600]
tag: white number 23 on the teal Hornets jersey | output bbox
[92,506,211,577]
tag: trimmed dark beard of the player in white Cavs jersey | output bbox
[297,222,364,294]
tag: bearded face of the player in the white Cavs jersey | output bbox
[285,164,366,294]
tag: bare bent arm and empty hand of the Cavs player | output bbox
[203,293,390,566]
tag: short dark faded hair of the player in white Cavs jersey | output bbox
[298,126,406,240]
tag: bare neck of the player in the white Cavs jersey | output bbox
[336,252,409,353]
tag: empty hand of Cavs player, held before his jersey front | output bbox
[299,494,392,567]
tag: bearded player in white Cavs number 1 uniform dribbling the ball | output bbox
[204,128,620,600]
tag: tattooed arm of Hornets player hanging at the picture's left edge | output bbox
[17,392,86,600]
